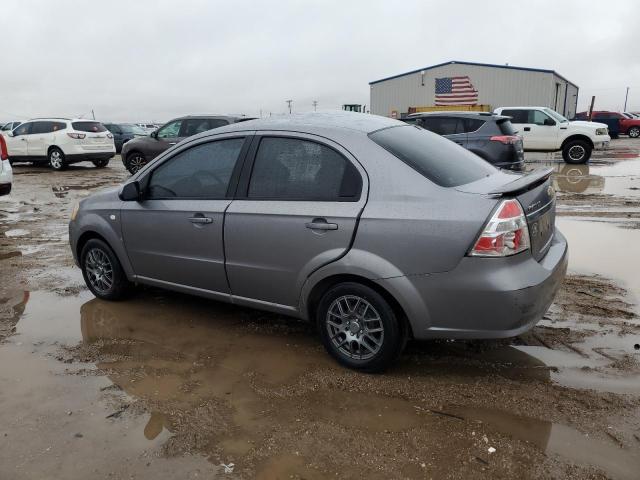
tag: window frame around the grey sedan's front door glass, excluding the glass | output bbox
[138,132,253,202]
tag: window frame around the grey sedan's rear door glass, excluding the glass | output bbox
[234,131,365,203]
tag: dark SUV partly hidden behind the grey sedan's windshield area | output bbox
[121,115,253,173]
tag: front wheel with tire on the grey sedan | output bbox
[80,238,131,300]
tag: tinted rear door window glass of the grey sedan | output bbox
[248,137,362,201]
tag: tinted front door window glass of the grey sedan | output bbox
[147,137,244,199]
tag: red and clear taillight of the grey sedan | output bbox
[469,199,531,257]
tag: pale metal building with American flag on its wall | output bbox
[369,61,578,118]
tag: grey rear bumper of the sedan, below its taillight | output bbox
[379,230,568,339]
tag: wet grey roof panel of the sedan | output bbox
[201,110,406,134]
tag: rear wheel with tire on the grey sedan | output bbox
[316,282,407,372]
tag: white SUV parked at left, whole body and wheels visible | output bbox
[5,118,116,170]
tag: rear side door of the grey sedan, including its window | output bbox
[224,132,367,309]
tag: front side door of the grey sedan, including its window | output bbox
[122,135,248,298]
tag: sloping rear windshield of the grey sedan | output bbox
[369,125,496,187]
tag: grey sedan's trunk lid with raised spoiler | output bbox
[456,168,556,261]
